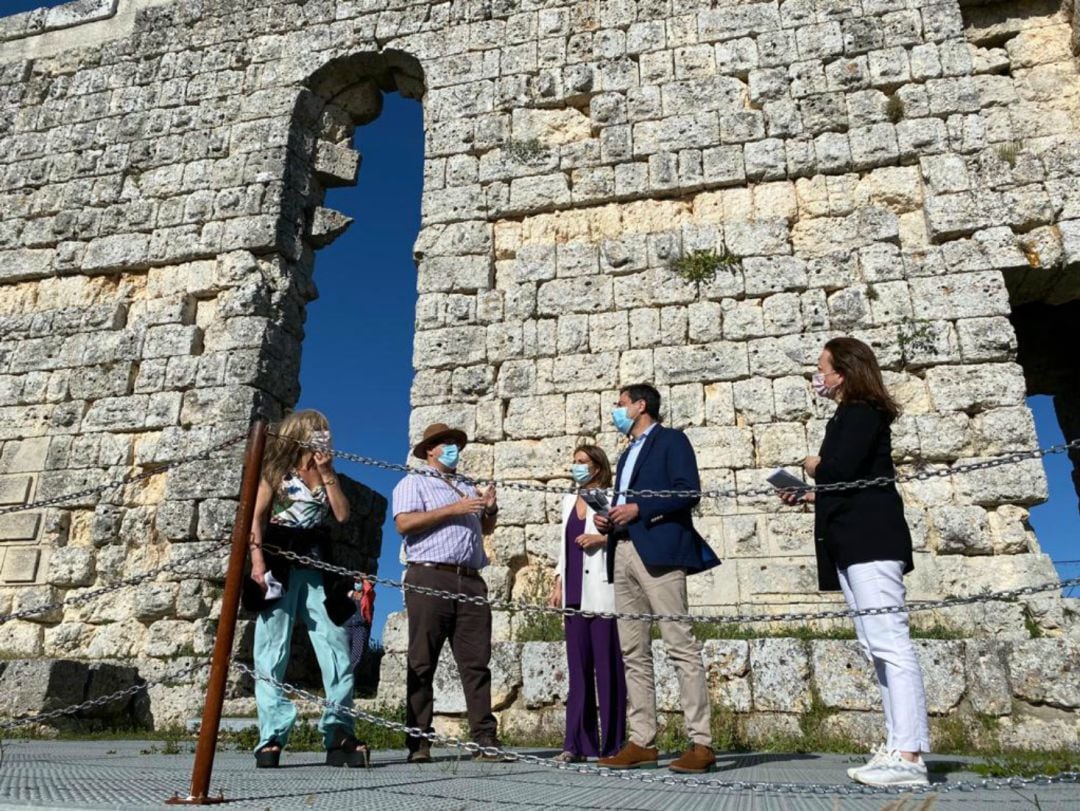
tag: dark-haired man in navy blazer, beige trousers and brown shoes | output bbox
[596,383,719,774]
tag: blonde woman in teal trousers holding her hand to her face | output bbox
[245,410,367,768]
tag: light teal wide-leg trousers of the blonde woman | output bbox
[255,569,355,748]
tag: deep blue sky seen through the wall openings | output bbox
[0,0,1080,636]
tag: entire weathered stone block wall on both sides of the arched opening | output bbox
[0,0,1080,740]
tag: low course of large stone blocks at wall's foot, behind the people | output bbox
[380,636,1080,751]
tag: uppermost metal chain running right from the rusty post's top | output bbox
[269,432,1080,499]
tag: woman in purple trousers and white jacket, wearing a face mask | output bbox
[549,445,626,763]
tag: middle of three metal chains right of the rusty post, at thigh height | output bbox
[262,543,1080,624]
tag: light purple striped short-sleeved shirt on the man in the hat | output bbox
[393,467,487,569]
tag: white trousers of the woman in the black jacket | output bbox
[838,560,930,752]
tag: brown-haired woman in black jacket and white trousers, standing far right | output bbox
[784,338,930,785]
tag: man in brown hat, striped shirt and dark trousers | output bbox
[393,422,500,763]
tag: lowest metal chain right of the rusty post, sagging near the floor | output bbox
[234,662,1080,796]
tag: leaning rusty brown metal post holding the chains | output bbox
[167,420,267,806]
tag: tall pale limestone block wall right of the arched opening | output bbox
[413,2,1080,634]
